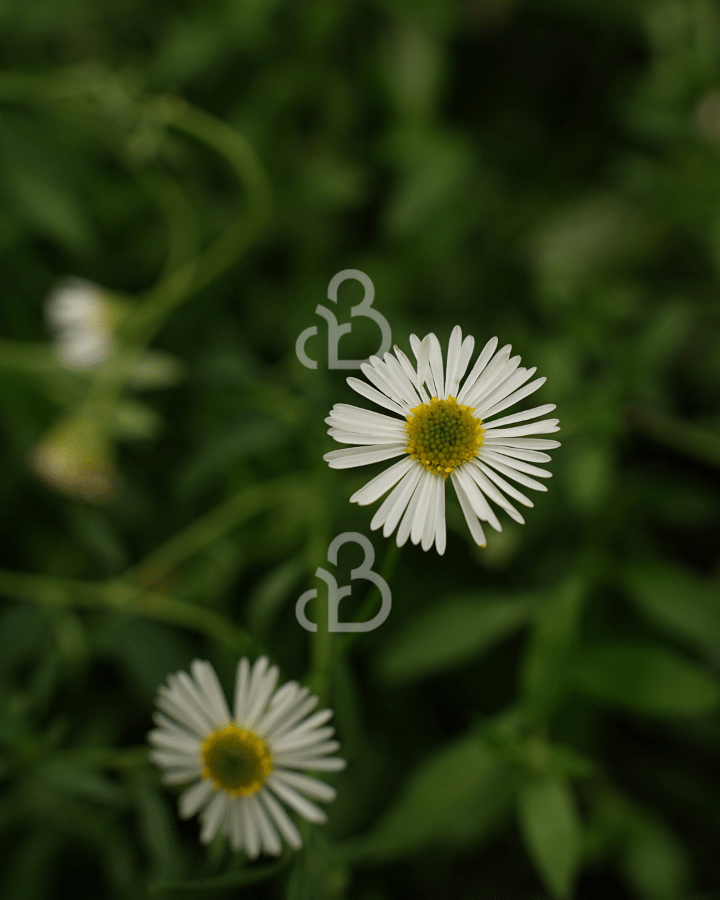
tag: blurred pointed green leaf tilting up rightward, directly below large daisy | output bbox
[378,594,536,683]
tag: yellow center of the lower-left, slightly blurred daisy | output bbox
[200,722,272,799]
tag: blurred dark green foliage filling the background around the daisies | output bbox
[0,0,720,900]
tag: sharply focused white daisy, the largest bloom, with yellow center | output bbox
[323,325,560,554]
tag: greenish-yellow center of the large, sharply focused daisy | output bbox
[405,397,485,478]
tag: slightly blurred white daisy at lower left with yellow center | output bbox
[148,656,345,859]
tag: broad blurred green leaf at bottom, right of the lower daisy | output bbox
[361,735,515,859]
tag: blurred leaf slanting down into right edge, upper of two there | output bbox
[622,562,720,662]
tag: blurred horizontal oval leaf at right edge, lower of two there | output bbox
[574,643,720,716]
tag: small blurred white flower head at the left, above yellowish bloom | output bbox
[46,278,117,369]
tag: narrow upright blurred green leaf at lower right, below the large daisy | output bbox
[521,578,586,722]
